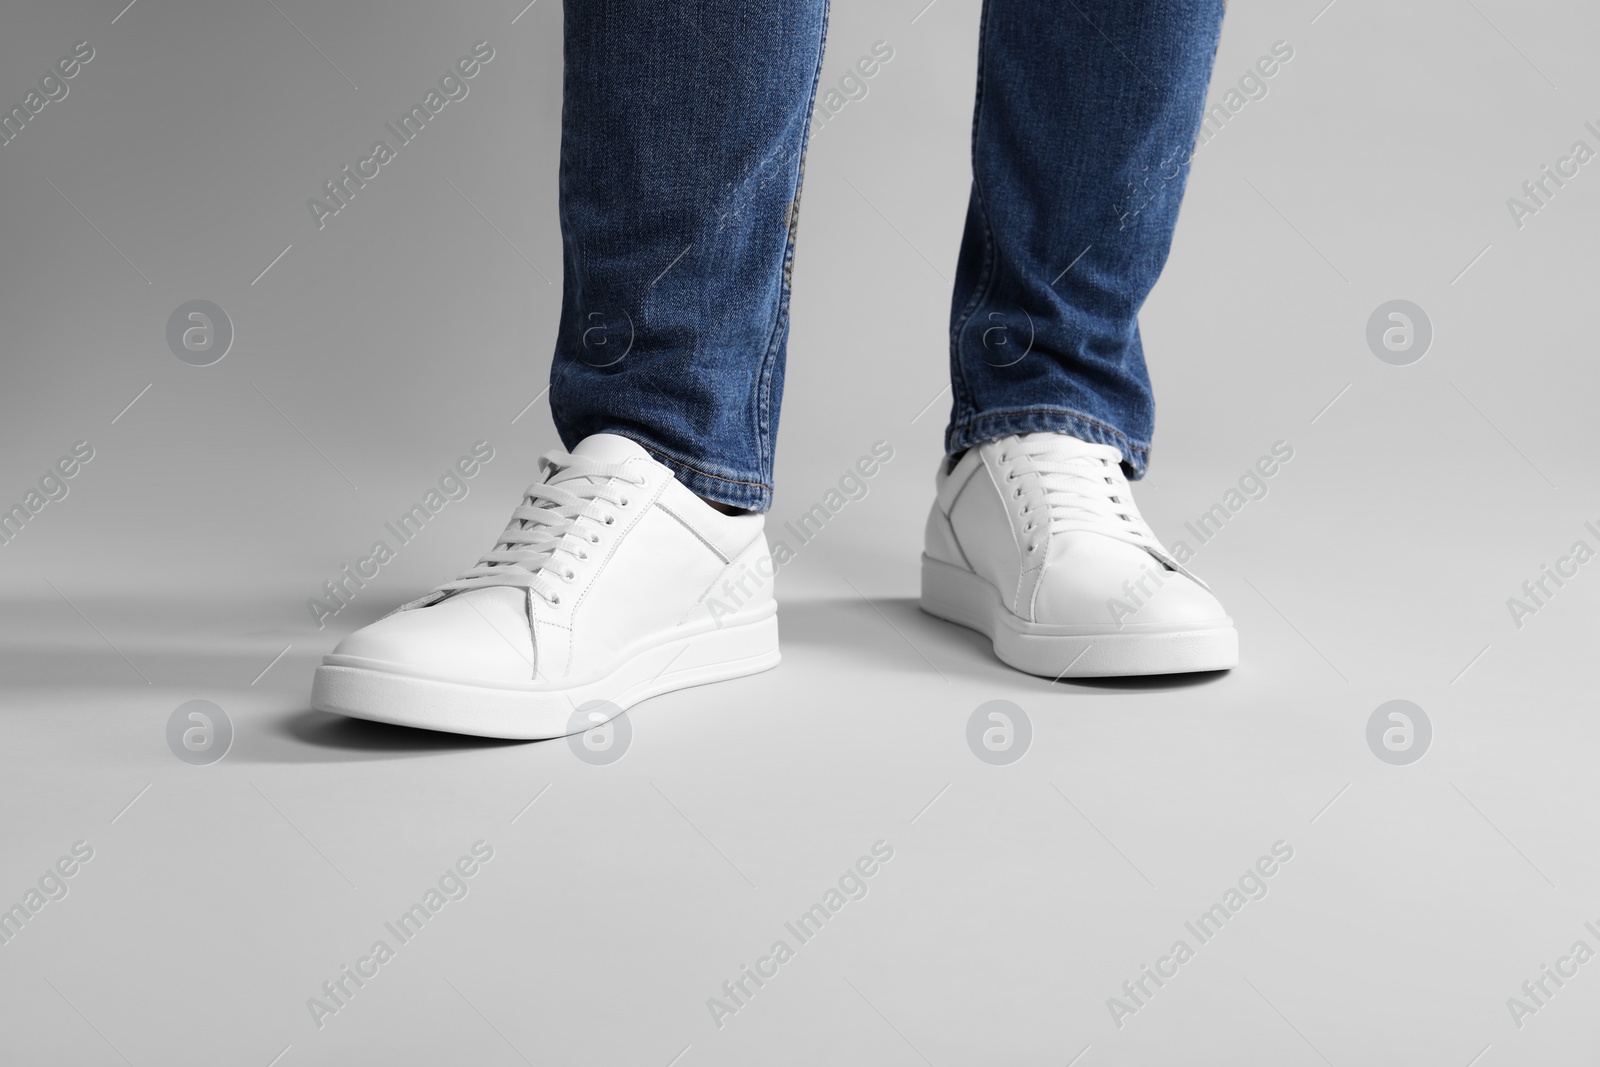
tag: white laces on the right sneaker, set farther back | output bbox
[1000,434,1170,561]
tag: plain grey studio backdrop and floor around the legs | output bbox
[0,0,1600,1067]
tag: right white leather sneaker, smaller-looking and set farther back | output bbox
[922,434,1238,678]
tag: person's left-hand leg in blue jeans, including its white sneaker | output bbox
[312,0,827,737]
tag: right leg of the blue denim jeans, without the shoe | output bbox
[946,0,1222,478]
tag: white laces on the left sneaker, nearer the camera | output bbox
[434,450,645,605]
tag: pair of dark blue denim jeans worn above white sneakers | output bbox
[550,0,1222,510]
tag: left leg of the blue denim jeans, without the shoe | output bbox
[550,0,827,510]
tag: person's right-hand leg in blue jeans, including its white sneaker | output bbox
[922,0,1238,678]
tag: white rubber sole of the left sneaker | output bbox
[310,605,779,741]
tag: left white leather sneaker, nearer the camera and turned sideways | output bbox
[312,434,778,737]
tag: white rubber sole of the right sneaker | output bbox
[922,555,1238,678]
